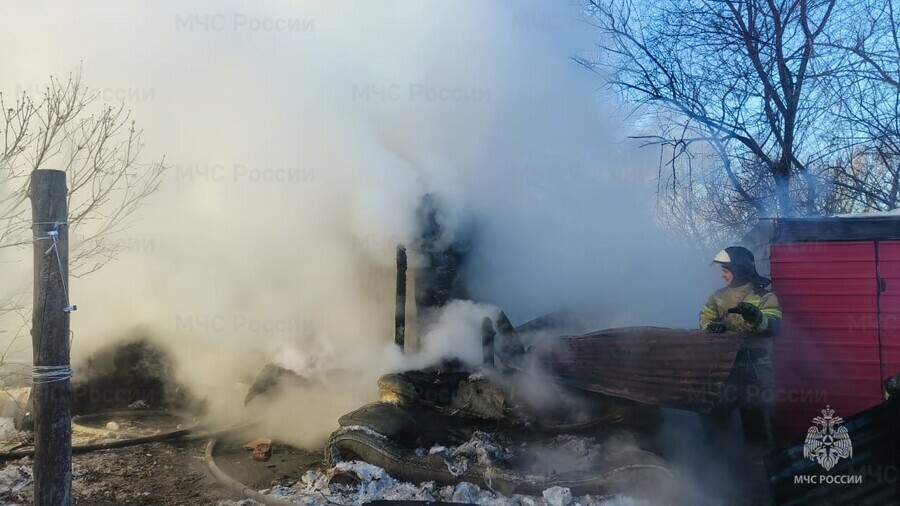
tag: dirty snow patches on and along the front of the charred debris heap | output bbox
[250,432,644,506]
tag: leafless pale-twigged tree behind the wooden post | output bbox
[0,73,165,386]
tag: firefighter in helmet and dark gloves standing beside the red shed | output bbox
[700,246,781,449]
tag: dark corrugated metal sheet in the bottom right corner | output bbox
[766,399,900,506]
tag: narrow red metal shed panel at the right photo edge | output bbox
[878,241,900,379]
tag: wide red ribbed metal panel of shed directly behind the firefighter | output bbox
[771,241,881,442]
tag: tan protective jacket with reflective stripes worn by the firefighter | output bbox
[700,282,781,337]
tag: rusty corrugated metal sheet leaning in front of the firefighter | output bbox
[536,327,745,412]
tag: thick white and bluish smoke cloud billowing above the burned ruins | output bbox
[0,0,714,443]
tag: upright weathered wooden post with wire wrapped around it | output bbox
[29,170,74,506]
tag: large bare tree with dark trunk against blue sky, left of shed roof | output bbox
[577,0,836,242]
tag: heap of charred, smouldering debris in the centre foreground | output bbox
[326,369,675,499]
